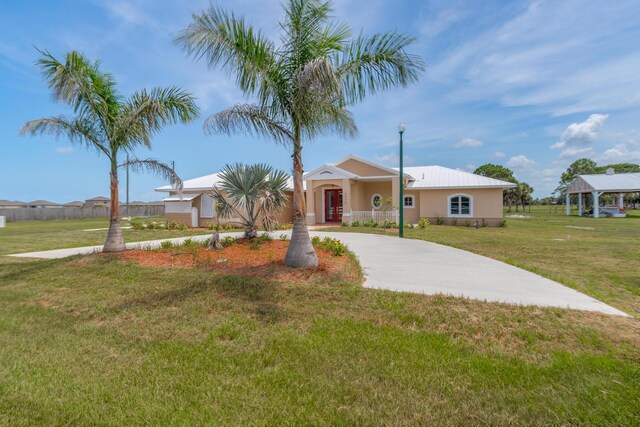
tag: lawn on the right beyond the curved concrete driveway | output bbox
[329,206,640,317]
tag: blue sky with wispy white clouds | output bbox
[0,0,640,202]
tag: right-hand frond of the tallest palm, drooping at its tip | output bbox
[334,33,425,103]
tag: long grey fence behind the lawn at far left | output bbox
[0,206,164,222]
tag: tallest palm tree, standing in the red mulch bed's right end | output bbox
[176,0,424,267]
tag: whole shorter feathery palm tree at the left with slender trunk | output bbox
[20,51,198,252]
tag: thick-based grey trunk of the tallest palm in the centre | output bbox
[284,139,318,268]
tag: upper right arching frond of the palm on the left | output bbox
[113,86,199,149]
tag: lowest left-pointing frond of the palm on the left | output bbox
[20,116,113,158]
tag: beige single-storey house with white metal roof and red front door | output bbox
[156,155,515,226]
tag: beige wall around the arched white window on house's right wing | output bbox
[420,188,503,225]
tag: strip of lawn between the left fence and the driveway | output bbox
[0,218,214,262]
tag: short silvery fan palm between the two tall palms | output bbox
[209,163,289,239]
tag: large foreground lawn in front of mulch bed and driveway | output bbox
[0,256,640,425]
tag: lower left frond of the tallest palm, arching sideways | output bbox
[204,104,293,145]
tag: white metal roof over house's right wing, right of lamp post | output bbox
[404,166,516,189]
